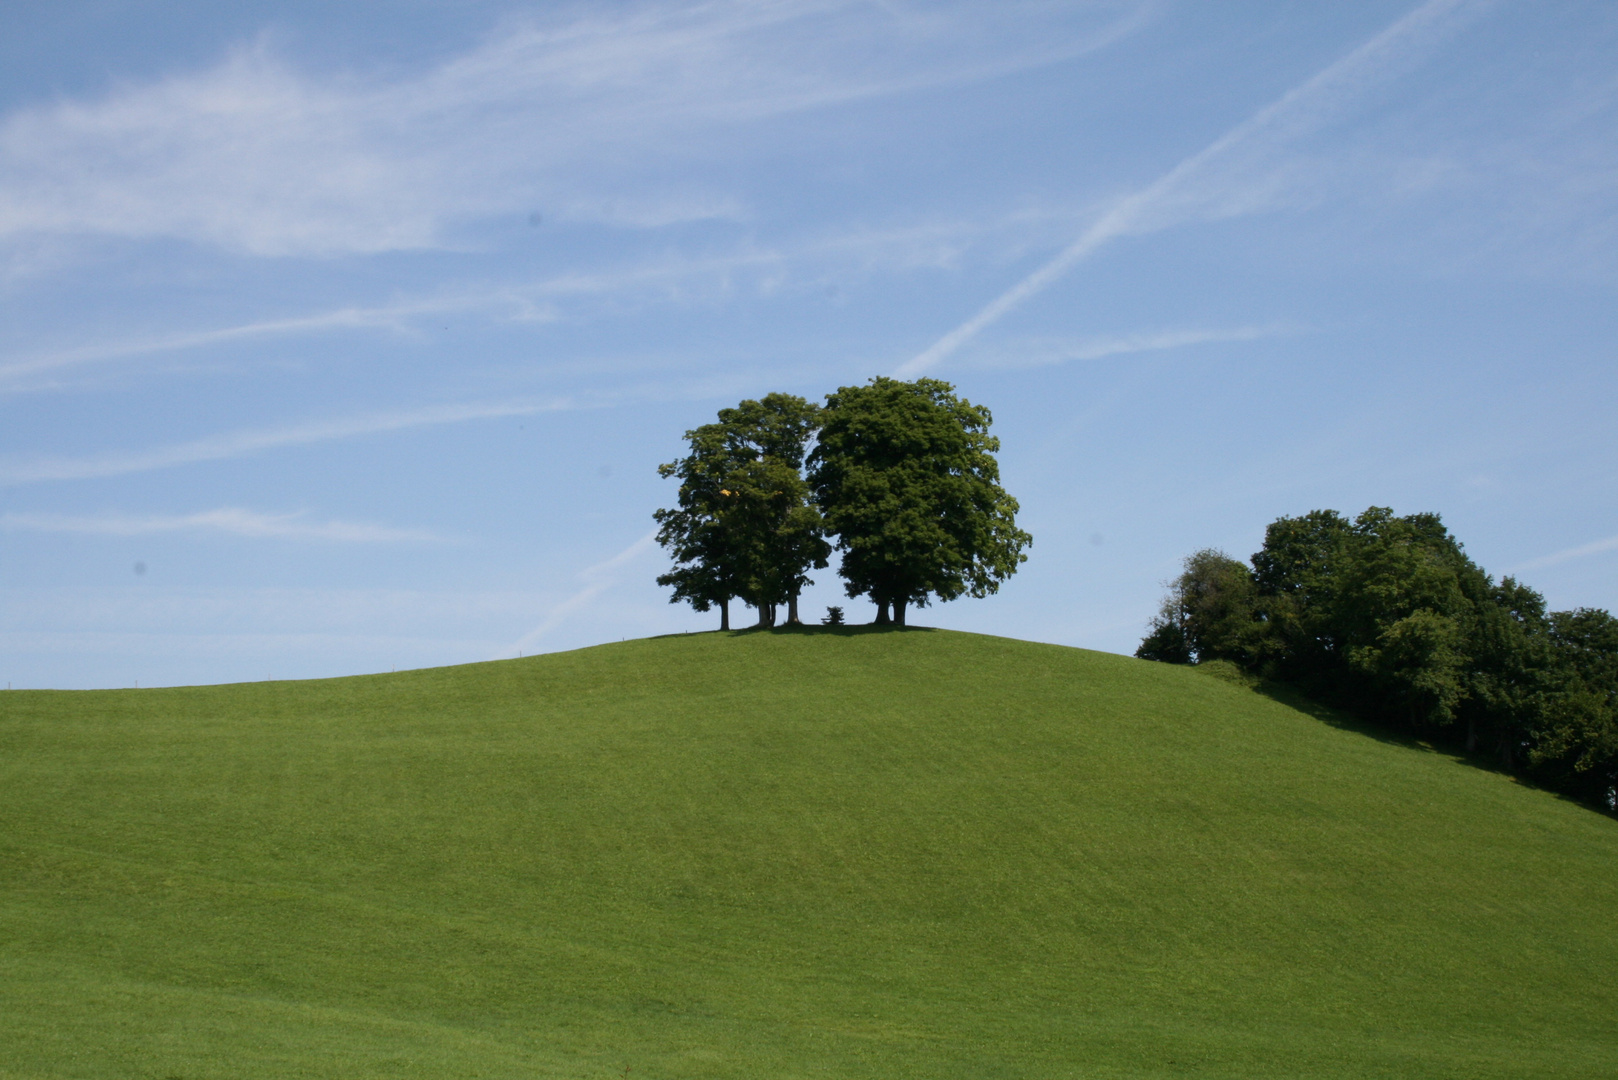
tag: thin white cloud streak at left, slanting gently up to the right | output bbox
[0,400,579,487]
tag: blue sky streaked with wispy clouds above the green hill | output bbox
[0,0,1618,687]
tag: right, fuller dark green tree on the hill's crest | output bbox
[809,377,1031,625]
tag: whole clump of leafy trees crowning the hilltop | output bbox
[654,377,1031,630]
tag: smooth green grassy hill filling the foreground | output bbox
[0,628,1618,1080]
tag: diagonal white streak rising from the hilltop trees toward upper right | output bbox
[895,0,1484,377]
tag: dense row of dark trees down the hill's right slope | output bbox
[1136,507,1618,808]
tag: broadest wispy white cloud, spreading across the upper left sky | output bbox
[0,0,1150,256]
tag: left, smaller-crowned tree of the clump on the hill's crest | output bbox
[654,393,830,630]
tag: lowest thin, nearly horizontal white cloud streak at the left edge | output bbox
[0,507,445,544]
